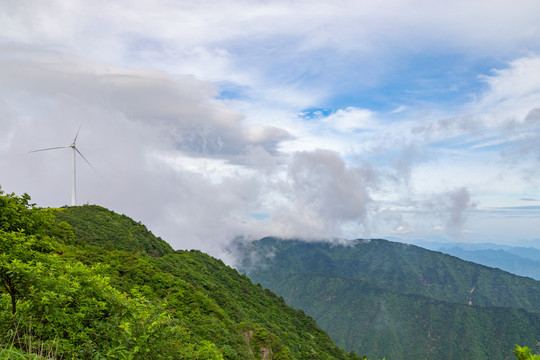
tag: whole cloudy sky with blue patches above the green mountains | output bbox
[0,0,540,256]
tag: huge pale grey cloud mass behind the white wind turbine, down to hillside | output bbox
[0,53,290,252]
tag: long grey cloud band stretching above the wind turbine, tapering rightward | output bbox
[0,48,291,158]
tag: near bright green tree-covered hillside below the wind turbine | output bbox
[0,190,360,360]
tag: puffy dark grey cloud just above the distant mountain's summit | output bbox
[275,150,375,238]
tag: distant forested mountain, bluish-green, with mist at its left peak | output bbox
[239,238,540,359]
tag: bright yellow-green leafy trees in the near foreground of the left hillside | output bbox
[0,232,202,359]
